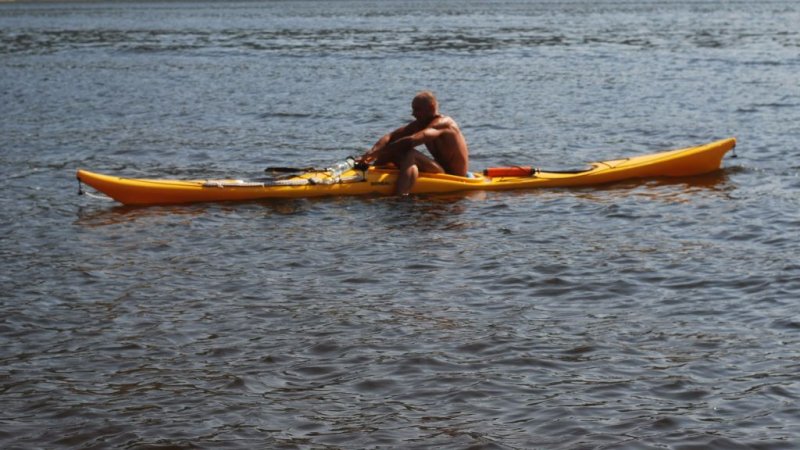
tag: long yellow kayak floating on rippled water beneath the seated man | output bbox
[77,138,736,205]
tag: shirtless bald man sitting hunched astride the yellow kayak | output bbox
[359,91,469,195]
